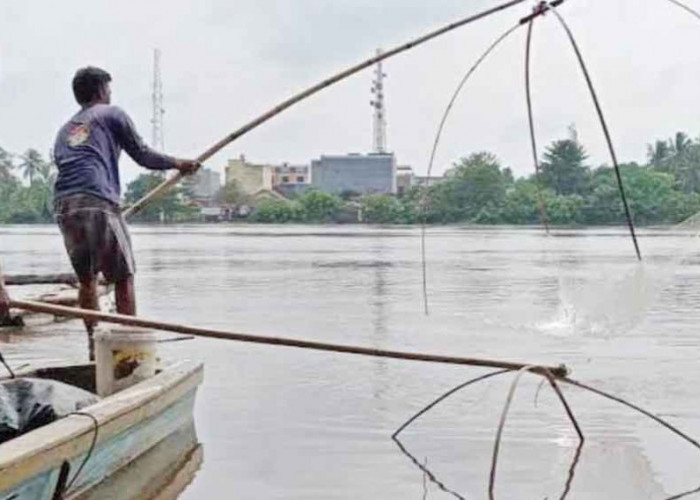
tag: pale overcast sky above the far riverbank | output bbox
[0,0,700,183]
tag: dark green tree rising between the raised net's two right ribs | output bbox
[541,139,589,195]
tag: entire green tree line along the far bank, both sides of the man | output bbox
[0,132,700,225]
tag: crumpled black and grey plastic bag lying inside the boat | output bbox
[0,378,99,443]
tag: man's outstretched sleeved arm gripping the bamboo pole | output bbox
[107,106,200,174]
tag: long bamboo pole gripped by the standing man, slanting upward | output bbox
[124,0,525,217]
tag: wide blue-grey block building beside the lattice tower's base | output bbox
[311,153,396,194]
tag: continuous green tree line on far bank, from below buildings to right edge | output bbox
[245,132,700,225]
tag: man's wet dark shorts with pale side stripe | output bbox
[54,194,136,283]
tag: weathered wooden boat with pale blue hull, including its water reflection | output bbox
[0,361,203,500]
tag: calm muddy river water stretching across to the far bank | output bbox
[0,225,700,500]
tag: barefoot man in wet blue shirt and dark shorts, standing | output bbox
[54,67,200,358]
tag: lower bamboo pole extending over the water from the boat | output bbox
[10,300,569,377]
